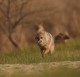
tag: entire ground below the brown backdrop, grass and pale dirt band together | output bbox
[0,38,80,77]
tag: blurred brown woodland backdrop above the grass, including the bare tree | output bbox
[0,0,80,51]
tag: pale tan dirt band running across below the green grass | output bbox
[0,61,80,74]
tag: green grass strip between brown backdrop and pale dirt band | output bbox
[0,38,80,64]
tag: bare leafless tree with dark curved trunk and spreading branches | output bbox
[0,0,53,48]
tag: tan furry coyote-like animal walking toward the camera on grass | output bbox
[35,25,54,57]
